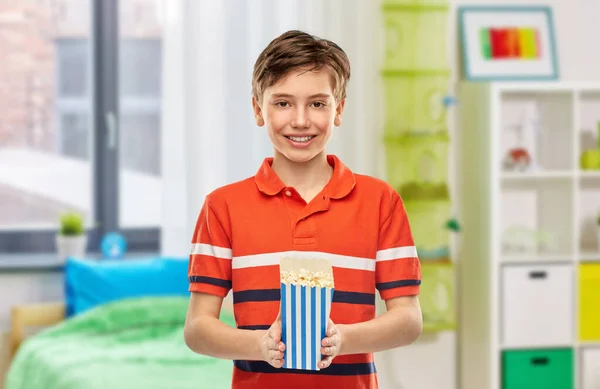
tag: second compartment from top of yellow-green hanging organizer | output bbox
[383,71,449,136]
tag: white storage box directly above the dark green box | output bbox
[501,265,574,347]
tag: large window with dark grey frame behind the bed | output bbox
[0,0,162,254]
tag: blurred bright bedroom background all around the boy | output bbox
[0,0,600,389]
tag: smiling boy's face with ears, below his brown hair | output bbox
[252,68,344,163]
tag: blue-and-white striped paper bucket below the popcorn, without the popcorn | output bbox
[281,283,333,370]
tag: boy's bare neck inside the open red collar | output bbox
[271,152,333,203]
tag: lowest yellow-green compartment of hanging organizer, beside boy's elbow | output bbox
[419,263,456,332]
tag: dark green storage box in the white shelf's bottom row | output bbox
[502,349,574,389]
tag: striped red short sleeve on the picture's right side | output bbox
[375,192,421,300]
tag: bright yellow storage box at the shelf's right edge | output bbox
[579,263,600,342]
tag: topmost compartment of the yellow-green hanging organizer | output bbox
[383,2,449,70]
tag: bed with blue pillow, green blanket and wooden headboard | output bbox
[5,259,235,389]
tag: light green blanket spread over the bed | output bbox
[6,297,235,389]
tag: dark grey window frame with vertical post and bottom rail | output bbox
[0,0,161,255]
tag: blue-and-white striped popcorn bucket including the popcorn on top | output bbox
[281,258,334,370]
